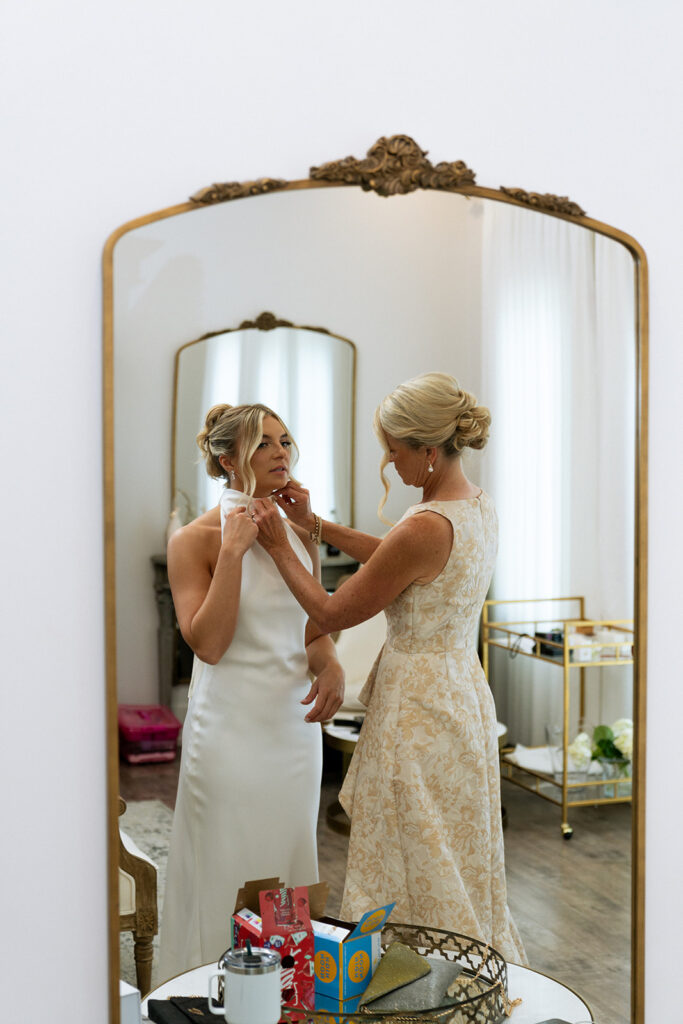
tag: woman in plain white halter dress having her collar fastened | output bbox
[159,404,344,978]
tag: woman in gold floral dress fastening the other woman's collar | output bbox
[254,374,525,963]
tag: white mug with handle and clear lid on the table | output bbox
[209,947,281,1024]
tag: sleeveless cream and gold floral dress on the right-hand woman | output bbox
[340,492,526,964]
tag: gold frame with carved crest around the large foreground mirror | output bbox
[102,135,648,1024]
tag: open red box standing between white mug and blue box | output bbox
[231,879,328,1010]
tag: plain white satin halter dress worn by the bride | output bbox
[159,488,323,979]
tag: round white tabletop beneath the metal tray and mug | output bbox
[142,964,592,1024]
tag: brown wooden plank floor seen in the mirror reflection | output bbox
[121,749,631,1024]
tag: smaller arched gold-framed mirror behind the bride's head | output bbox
[171,312,355,525]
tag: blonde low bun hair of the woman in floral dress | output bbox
[374,374,490,522]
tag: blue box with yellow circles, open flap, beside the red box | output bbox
[311,903,394,999]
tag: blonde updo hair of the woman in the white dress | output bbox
[197,403,299,496]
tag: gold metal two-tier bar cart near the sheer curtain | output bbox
[481,597,634,840]
